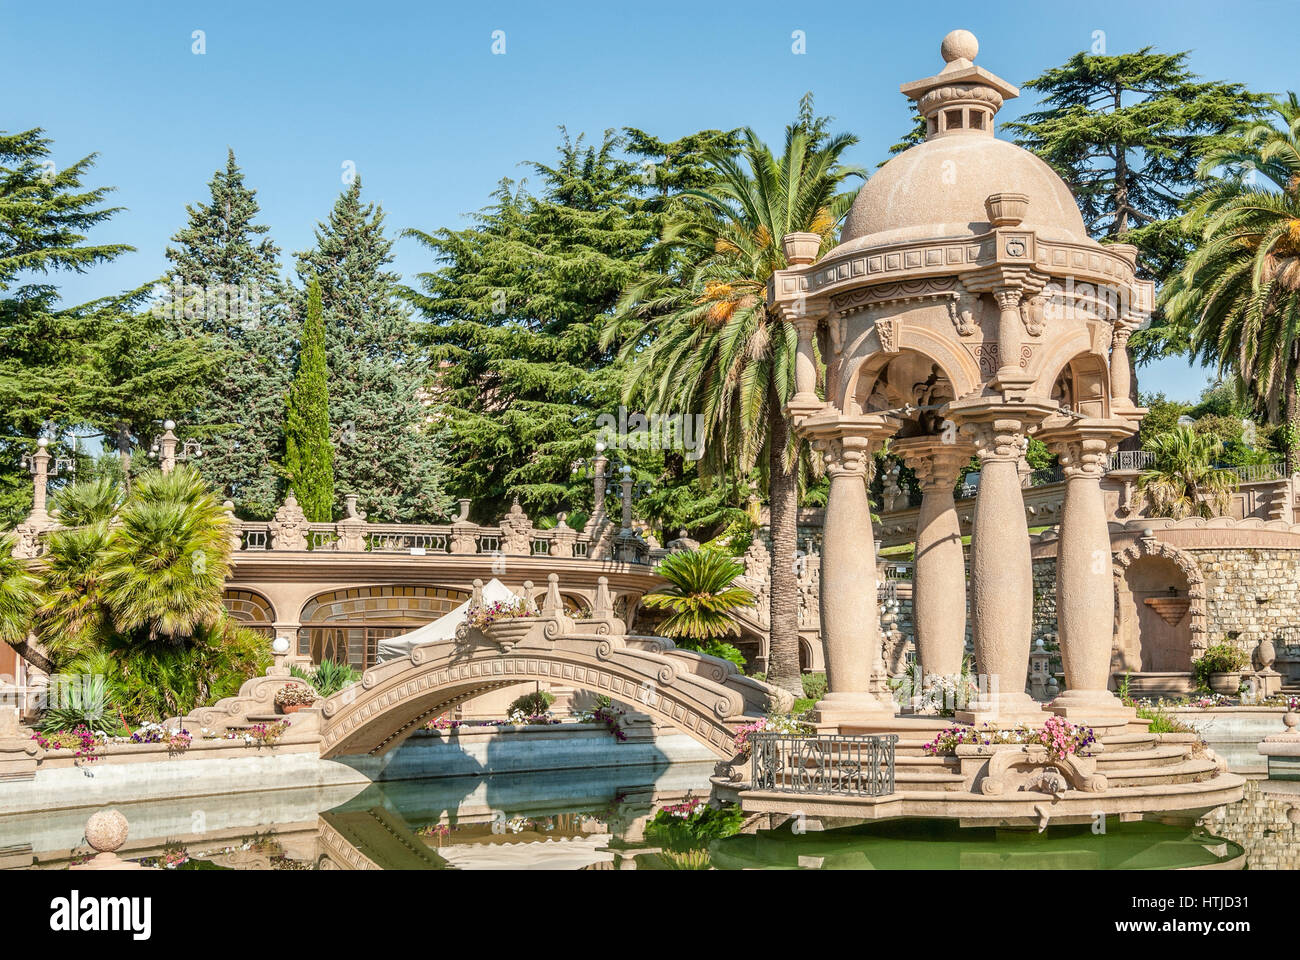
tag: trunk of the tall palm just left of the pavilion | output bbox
[767,392,803,697]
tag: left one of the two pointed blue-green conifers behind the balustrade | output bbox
[157,151,293,518]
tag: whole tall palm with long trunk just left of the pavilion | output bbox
[620,100,866,696]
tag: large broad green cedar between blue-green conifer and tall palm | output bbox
[403,131,658,518]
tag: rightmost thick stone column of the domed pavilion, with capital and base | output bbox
[1040,420,1135,719]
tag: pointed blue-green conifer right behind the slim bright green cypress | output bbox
[298,177,450,523]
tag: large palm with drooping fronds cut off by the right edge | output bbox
[1161,92,1300,473]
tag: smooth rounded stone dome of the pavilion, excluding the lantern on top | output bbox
[840,135,1088,248]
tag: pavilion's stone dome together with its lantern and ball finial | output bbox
[832,30,1088,252]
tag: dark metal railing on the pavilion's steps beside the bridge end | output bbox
[749,734,898,796]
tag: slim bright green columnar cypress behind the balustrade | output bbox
[285,280,334,523]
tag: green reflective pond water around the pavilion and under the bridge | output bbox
[0,764,1300,870]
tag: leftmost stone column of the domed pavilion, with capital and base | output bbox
[813,415,898,727]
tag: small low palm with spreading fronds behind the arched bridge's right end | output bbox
[641,549,754,640]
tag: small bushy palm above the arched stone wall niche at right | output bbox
[1138,427,1236,520]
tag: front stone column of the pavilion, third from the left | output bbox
[949,399,1054,725]
